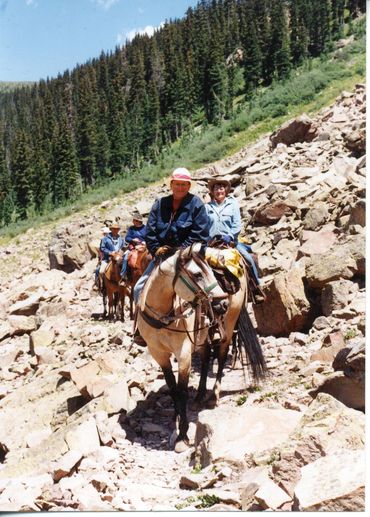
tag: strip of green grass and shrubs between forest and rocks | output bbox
[0,22,365,244]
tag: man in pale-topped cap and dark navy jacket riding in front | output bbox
[134,167,208,303]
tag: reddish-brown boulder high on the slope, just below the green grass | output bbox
[270,114,318,148]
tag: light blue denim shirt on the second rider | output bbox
[206,196,242,240]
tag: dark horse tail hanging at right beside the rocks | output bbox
[237,304,267,382]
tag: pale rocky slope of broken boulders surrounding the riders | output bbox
[0,84,366,511]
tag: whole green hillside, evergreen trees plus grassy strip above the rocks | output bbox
[0,0,365,232]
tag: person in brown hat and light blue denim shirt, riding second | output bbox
[206,177,263,302]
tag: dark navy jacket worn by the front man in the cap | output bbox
[145,193,209,255]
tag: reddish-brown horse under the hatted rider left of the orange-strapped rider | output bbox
[102,251,128,321]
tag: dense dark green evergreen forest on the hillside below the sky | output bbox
[0,0,365,227]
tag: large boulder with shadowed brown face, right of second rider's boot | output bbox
[254,269,310,337]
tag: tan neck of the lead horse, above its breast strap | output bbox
[143,266,175,314]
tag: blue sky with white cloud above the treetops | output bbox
[0,0,197,81]
